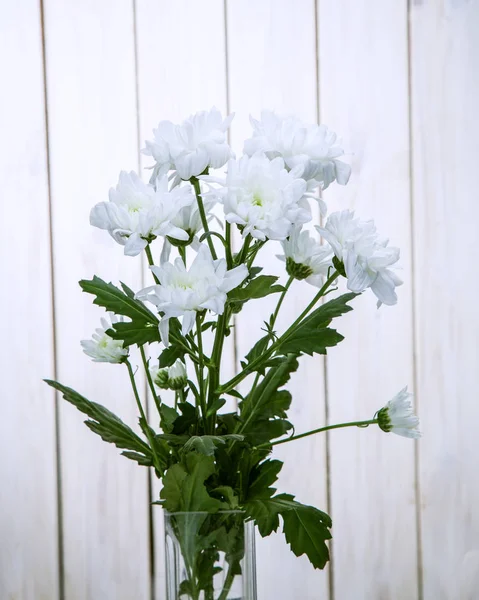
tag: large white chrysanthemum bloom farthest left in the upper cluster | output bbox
[90,171,195,256]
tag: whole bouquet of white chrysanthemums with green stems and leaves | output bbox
[48,109,420,600]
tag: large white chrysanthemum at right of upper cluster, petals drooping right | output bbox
[316,210,402,306]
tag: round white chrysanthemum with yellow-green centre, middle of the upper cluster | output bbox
[220,153,311,240]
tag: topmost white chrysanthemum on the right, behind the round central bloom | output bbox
[244,110,351,189]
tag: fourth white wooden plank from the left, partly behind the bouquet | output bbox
[227,0,328,600]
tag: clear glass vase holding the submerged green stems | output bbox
[164,511,256,600]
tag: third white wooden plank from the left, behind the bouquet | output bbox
[136,0,234,600]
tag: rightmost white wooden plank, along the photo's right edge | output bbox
[411,0,479,600]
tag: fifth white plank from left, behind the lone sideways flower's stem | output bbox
[319,0,418,600]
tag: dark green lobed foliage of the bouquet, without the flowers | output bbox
[47,268,356,580]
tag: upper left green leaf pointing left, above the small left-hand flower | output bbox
[80,275,159,326]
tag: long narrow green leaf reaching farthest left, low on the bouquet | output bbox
[45,379,151,460]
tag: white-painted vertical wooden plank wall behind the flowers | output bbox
[0,0,479,600]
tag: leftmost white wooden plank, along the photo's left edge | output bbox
[0,1,58,600]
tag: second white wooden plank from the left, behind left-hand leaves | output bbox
[45,0,150,600]
